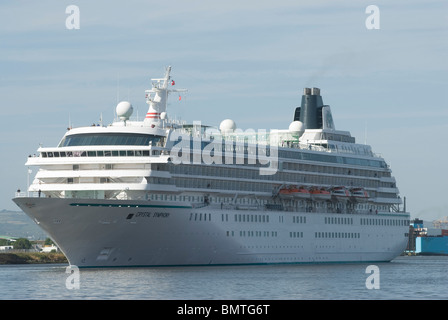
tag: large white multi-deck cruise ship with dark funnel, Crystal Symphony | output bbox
[13,67,410,268]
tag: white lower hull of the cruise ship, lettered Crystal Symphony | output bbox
[14,198,409,267]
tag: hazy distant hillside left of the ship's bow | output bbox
[0,210,48,240]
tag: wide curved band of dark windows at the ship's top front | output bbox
[59,133,161,147]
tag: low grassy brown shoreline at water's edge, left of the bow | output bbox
[0,252,68,265]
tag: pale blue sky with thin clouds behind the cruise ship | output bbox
[0,0,448,220]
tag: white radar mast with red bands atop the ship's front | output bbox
[144,66,187,126]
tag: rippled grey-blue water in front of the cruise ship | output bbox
[0,256,448,300]
